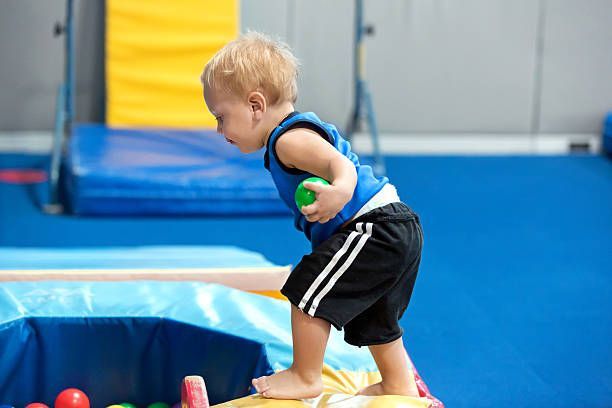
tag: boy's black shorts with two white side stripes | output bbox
[281,202,423,346]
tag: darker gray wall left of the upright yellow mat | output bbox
[0,0,104,131]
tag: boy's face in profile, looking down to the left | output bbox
[204,87,263,153]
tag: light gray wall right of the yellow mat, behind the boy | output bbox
[242,0,612,135]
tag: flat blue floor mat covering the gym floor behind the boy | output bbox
[0,151,612,408]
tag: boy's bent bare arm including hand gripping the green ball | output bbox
[276,129,357,223]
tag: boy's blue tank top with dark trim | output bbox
[265,112,389,248]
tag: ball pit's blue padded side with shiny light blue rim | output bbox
[0,281,376,407]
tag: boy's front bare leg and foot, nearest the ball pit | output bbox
[253,305,330,399]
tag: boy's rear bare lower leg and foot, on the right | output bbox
[358,337,419,397]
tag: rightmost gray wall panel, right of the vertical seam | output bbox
[539,0,612,133]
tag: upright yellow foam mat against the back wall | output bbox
[106,0,238,128]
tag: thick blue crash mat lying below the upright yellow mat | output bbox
[64,124,288,215]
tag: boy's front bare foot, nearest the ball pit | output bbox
[252,368,323,399]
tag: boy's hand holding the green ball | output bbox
[301,182,353,224]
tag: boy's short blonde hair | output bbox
[200,31,299,105]
